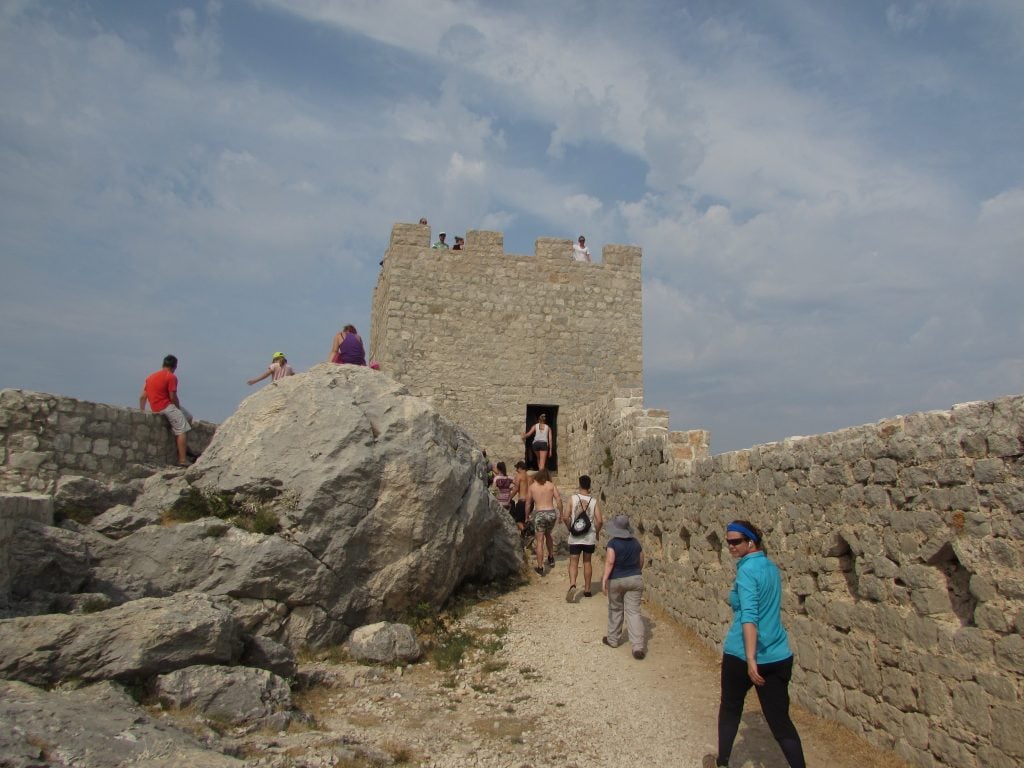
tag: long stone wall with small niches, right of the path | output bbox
[566,392,1024,768]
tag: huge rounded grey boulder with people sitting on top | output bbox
[91,364,522,648]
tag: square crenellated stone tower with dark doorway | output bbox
[370,224,643,479]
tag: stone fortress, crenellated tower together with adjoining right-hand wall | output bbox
[371,224,1024,768]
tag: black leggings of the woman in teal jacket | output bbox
[718,653,807,768]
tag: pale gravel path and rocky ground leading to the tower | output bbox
[199,557,903,768]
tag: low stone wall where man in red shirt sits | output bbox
[0,389,215,495]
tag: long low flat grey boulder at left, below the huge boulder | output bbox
[0,594,244,685]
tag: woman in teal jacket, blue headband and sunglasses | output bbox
[702,520,807,768]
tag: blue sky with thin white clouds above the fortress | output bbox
[0,0,1024,454]
